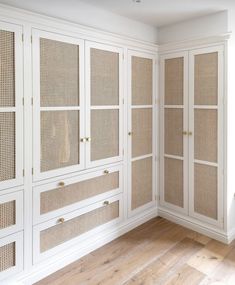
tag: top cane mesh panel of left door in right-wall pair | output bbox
[165,57,184,105]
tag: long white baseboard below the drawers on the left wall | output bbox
[16,208,158,285]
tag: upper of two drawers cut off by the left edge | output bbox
[0,191,23,238]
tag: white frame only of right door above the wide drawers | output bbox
[85,41,124,168]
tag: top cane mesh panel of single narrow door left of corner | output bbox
[132,56,153,105]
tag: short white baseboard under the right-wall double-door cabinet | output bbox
[158,207,229,244]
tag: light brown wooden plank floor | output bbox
[36,218,235,285]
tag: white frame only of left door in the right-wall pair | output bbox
[160,51,188,214]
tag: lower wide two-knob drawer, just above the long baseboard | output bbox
[33,194,123,262]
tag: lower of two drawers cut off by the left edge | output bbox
[0,232,23,284]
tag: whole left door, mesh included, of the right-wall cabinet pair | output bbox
[160,52,188,213]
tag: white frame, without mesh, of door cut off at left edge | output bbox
[0,22,24,191]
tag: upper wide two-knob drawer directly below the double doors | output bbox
[34,166,122,224]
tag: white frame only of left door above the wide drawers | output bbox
[32,28,85,181]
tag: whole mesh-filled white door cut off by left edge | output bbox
[0,23,23,190]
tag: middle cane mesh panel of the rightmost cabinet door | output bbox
[194,109,218,162]
